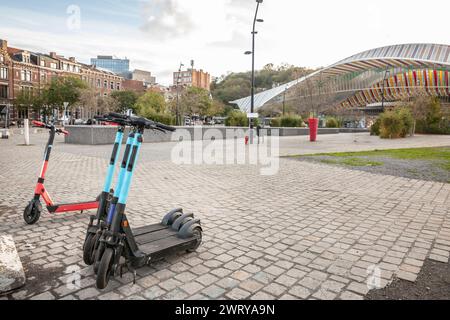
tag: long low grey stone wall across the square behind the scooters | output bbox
[65,126,370,145]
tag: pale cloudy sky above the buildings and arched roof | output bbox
[0,0,450,84]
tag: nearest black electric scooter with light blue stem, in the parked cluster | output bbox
[95,117,202,289]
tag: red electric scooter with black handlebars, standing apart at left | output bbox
[23,121,99,225]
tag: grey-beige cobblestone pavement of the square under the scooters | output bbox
[0,134,450,299]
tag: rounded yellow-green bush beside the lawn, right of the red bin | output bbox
[380,108,414,139]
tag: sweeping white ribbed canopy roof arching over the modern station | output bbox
[230,44,450,112]
